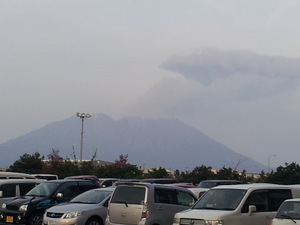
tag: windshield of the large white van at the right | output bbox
[193,189,247,210]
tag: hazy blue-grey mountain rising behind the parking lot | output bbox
[0,114,267,173]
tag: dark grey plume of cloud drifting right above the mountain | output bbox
[161,49,300,86]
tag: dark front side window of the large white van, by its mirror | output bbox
[242,190,268,213]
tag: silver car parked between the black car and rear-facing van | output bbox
[43,187,114,225]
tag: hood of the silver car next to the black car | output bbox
[47,203,102,213]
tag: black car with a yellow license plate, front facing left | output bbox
[0,179,100,225]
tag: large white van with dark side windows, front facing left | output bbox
[173,183,300,225]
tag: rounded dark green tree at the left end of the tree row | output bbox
[8,152,44,174]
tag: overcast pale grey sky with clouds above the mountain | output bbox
[0,0,300,167]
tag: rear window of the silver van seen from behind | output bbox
[110,186,146,205]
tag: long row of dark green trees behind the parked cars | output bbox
[7,149,300,185]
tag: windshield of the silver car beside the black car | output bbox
[71,190,112,204]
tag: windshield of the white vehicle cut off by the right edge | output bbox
[275,201,300,220]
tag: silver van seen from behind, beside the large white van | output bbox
[105,182,197,225]
